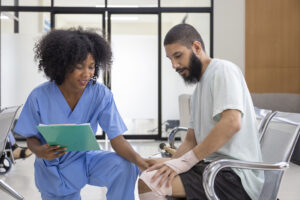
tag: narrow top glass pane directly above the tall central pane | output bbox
[107,0,157,8]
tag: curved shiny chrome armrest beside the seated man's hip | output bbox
[202,159,289,200]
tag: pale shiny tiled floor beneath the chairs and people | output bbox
[0,141,300,200]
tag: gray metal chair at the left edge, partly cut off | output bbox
[0,106,24,199]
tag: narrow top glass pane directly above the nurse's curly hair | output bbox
[54,0,105,7]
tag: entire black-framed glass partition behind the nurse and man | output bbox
[1,4,213,139]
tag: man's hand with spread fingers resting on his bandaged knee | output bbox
[147,163,177,187]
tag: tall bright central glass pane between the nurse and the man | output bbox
[111,15,158,135]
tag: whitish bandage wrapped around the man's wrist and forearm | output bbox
[164,150,199,174]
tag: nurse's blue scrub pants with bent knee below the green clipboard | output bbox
[39,151,139,200]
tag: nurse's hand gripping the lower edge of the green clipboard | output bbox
[36,144,67,160]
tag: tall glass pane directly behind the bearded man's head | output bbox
[162,13,210,137]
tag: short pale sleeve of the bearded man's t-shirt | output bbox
[212,65,244,121]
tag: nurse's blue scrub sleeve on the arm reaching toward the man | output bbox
[98,93,127,140]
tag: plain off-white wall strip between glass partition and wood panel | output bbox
[214,0,245,72]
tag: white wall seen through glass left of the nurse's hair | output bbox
[1,34,46,108]
